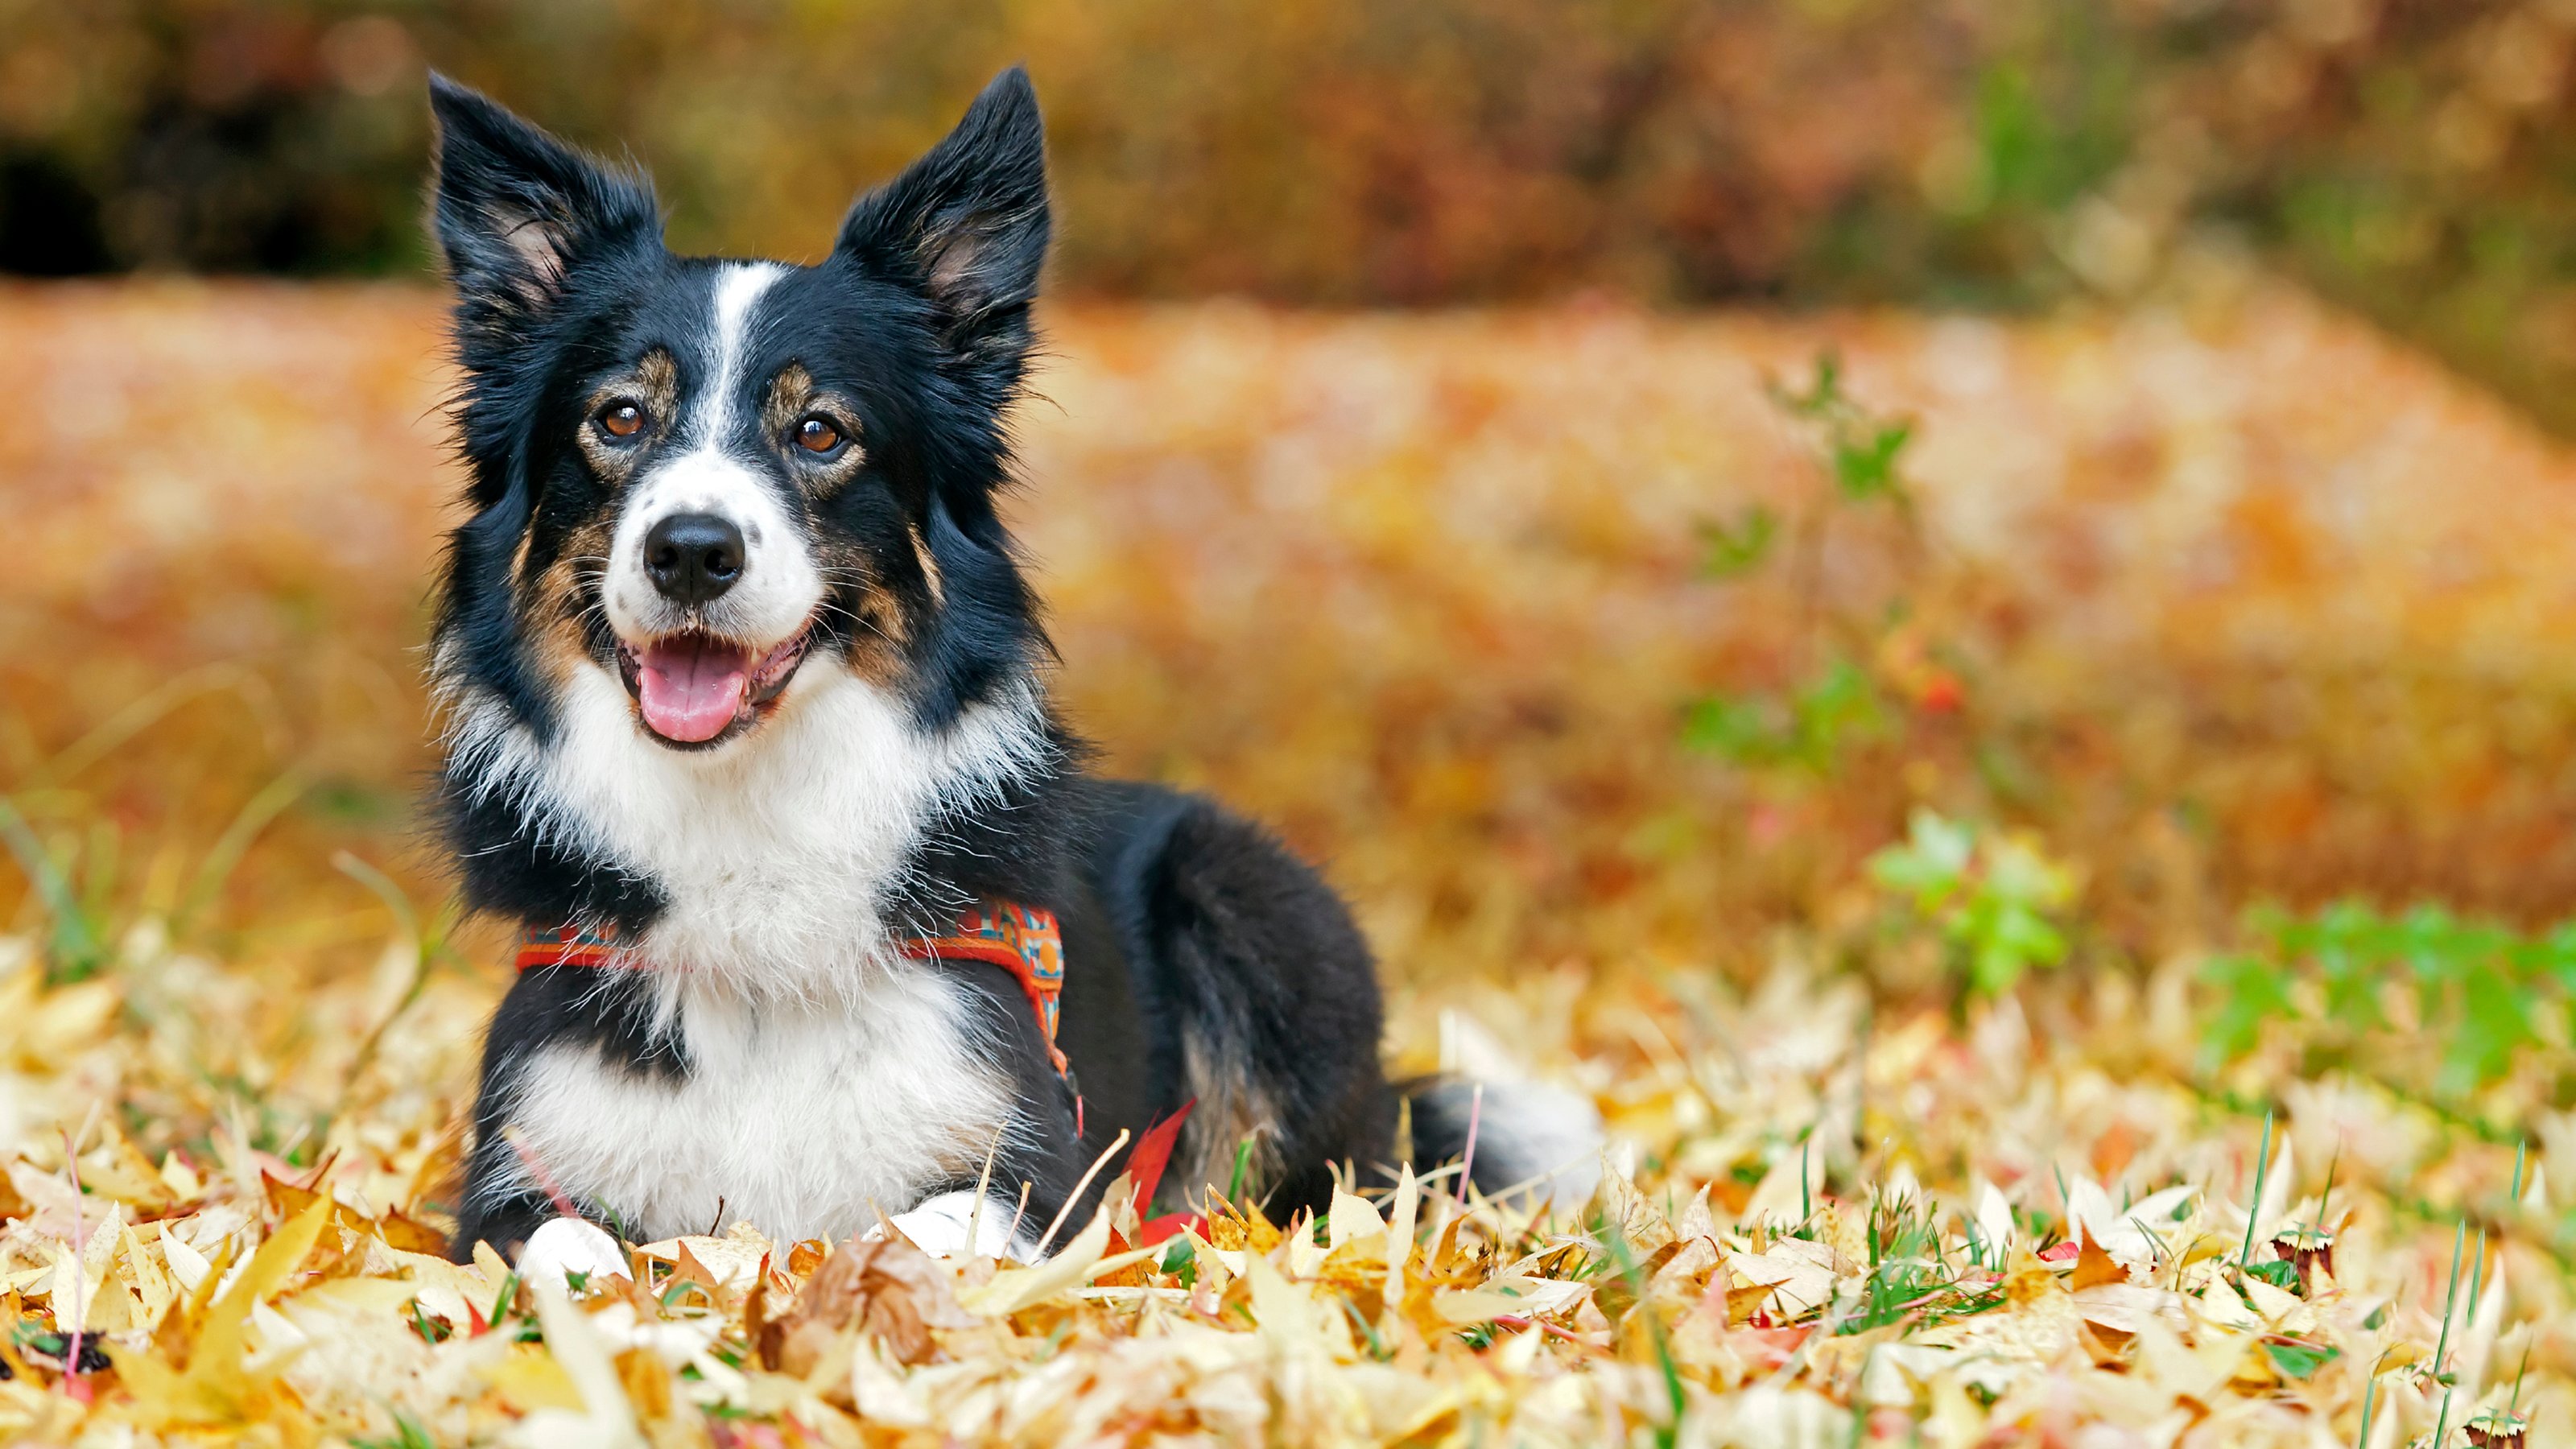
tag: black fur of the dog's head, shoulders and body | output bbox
[430,69,1504,1253]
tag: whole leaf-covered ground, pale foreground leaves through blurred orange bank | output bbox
[0,279,2576,1447]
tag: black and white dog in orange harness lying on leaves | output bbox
[430,69,1597,1253]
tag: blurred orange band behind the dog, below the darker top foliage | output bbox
[0,281,2576,977]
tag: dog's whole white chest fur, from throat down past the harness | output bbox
[456,658,1046,1241]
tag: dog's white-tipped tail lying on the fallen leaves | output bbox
[1396,1075,1602,1212]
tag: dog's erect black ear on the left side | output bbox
[430,72,659,315]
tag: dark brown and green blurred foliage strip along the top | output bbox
[14,0,2576,425]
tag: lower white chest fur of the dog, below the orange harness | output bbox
[510,969,1013,1241]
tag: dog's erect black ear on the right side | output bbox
[840,67,1048,353]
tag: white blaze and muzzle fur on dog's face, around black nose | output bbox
[601,263,824,650]
